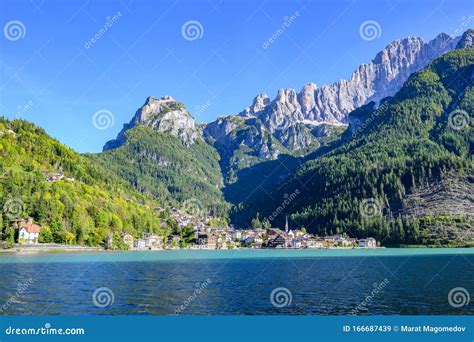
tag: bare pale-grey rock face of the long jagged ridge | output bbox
[210,33,460,150]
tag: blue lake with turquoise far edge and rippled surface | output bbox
[0,248,474,315]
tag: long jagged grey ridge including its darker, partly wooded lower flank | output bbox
[204,33,460,183]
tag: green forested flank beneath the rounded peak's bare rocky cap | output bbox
[87,126,228,217]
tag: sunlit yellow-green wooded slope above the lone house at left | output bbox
[0,118,164,247]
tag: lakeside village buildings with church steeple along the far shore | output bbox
[7,209,377,250]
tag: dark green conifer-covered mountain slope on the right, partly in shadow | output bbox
[233,48,474,244]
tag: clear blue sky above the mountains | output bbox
[0,0,474,152]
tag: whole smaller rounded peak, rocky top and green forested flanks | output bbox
[93,96,228,217]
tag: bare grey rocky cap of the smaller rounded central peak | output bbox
[103,96,200,151]
